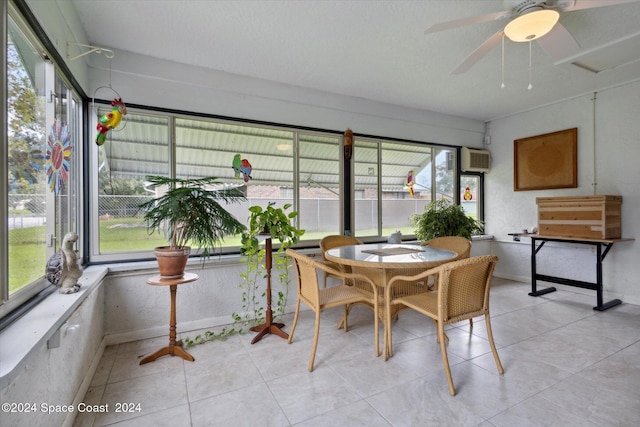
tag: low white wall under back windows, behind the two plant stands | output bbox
[103,256,250,345]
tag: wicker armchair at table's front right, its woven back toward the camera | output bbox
[386,255,504,396]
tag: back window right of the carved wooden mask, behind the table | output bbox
[353,138,457,238]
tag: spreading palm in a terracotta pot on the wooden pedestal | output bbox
[139,175,246,278]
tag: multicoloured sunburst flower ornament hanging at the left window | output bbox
[45,119,73,194]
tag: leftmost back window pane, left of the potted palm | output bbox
[95,107,169,260]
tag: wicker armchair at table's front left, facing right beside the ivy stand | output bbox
[287,249,380,372]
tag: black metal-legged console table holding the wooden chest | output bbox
[519,234,634,311]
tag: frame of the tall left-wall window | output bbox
[0,1,84,320]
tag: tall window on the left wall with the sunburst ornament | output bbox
[0,11,82,316]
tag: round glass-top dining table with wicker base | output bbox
[324,243,458,360]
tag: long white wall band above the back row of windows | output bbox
[87,51,484,147]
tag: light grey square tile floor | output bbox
[75,278,640,427]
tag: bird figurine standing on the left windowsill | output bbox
[45,232,82,294]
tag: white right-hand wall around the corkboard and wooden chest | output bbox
[485,82,640,304]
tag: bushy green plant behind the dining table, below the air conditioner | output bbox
[409,199,484,242]
